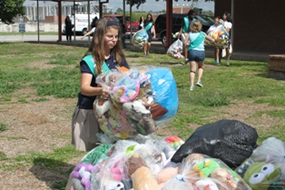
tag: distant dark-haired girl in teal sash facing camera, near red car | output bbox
[143,13,156,56]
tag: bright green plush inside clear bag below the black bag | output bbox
[193,159,220,178]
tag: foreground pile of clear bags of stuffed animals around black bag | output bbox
[66,119,285,190]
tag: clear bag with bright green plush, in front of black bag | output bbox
[160,153,251,190]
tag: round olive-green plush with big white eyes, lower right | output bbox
[243,162,281,190]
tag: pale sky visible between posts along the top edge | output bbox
[24,0,214,12]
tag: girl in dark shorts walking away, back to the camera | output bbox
[184,20,214,91]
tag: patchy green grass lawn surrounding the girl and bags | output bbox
[0,42,285,189]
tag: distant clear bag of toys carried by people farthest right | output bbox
[205,25,230,48]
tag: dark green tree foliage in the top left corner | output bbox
[0,0,25,24]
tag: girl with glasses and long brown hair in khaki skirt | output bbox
[72,17,129,151]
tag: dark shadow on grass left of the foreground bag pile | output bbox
[29,158,75,190]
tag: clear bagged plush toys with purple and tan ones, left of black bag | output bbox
[66,135,181,190]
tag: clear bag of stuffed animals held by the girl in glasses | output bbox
[93,67,178,139]
